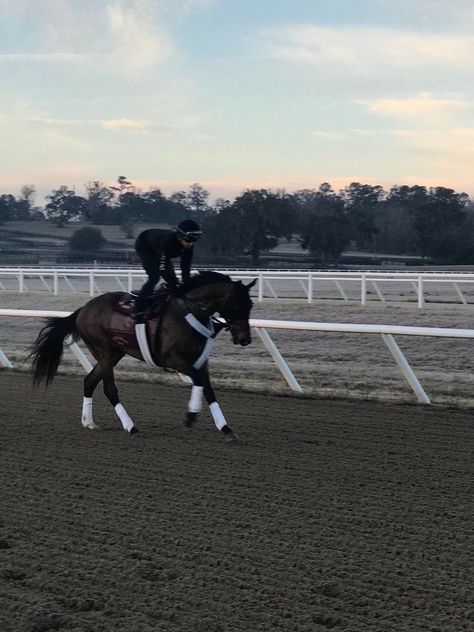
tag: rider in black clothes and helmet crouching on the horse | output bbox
[135,219,202,316]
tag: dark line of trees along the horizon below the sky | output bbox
[0,176,474,266]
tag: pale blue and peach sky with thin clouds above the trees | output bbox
[0,0,474,199]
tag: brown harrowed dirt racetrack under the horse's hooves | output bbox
[0,370,474,632]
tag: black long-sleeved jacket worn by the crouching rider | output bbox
[135,228,194,284]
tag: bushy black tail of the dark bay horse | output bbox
[29,309,80,386]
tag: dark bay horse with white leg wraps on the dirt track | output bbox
[29,271,257,441]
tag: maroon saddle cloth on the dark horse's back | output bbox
[107,292,171,366]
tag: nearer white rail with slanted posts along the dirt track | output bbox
[0,309,474,404]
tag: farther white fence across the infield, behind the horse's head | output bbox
[0,267,474,307]
